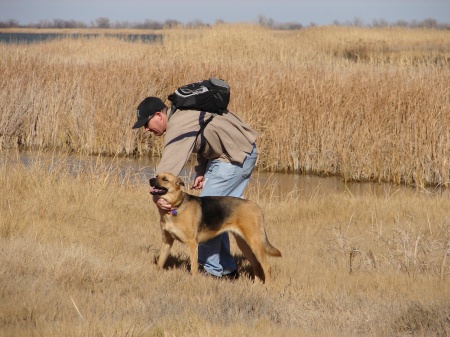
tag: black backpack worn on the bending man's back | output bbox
[168,77,230,115]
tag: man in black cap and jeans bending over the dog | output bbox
[133,97,258,278]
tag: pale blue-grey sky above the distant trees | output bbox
[0,0,450,25]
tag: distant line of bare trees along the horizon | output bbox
[0,15,450,30]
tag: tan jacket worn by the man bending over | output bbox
[155,110,258,175]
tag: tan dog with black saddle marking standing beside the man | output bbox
[150,173,281,282]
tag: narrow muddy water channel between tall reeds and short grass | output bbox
[5,151,450,198]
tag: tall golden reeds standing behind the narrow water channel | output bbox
[0,24,450,186]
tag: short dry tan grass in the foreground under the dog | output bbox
[0,153,450,336]
